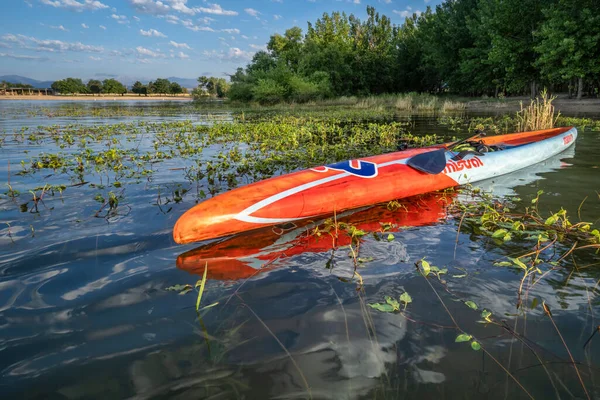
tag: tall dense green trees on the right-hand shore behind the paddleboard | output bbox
[228,0,600,103]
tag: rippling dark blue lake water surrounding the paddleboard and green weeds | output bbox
[0,101,600,399]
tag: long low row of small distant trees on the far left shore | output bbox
[51,78,187,95]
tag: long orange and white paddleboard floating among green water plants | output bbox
[173,127,577,243]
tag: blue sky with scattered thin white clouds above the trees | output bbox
[0,0,441,80]
